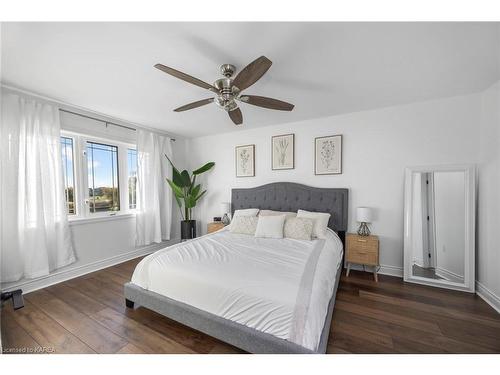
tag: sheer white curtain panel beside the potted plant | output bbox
[136,130,172,246]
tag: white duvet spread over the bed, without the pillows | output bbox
[132,229,342,350]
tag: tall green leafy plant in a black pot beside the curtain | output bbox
[165,155,215,240]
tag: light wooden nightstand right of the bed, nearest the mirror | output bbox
[346,233,379,281]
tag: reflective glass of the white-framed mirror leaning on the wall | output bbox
[410,171,466,283]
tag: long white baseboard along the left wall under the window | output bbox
[2,239,179,294]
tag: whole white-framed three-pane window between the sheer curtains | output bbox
[61,130,137,220]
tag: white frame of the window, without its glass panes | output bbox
[60,130,137,221]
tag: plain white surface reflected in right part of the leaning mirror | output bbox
[434,172,465,282]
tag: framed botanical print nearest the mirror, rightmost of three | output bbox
[314,135,342,175]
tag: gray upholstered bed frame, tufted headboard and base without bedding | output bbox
[124,182,348,354]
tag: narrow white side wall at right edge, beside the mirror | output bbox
[476,82,500,311]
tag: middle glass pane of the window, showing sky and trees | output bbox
[87,142,120,213]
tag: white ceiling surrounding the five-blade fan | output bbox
[1,23,500,137]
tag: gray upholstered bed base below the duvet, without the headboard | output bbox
[124,265,342,354]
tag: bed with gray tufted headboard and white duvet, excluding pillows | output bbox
[124,182,348,353]
